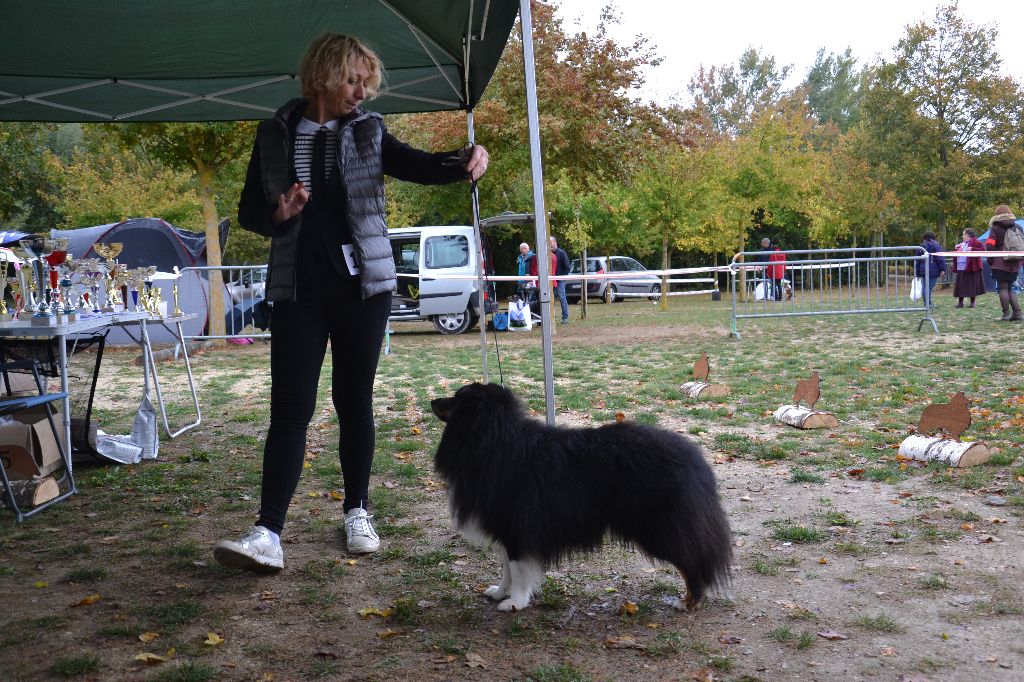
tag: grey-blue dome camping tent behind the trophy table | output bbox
[50,218,228,344]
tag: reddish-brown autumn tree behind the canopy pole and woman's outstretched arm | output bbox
[389,2,658,259]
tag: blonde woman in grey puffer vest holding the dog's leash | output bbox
[214,34,487,572]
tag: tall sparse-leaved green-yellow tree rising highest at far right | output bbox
[863,2,1014,244]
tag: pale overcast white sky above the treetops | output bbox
[558,0,1024,103]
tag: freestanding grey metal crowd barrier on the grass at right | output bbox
[729,247,939,338]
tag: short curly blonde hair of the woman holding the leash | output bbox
[299,33,384,99]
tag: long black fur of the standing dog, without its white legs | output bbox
[430,383,732,608]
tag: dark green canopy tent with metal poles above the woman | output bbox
[0,0,554,423]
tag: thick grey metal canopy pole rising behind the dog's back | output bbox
[519,0,555,425]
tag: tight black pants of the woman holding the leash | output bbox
[257,268,391,534]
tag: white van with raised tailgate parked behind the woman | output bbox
[388,214,534,334]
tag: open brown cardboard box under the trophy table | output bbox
[0,404,63,479]
